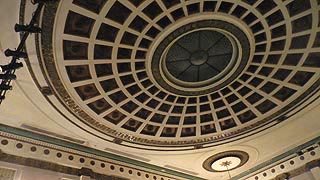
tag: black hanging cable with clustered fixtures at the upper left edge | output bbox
[0,0,53,104]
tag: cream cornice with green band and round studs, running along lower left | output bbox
[0,124,203,180]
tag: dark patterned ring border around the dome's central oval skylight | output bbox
[151,20,250,96]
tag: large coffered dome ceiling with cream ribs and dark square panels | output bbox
[39,0,320,148]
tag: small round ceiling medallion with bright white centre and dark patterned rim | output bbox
[202,151,249,172]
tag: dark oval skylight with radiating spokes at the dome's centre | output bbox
[164,30,233,83]
